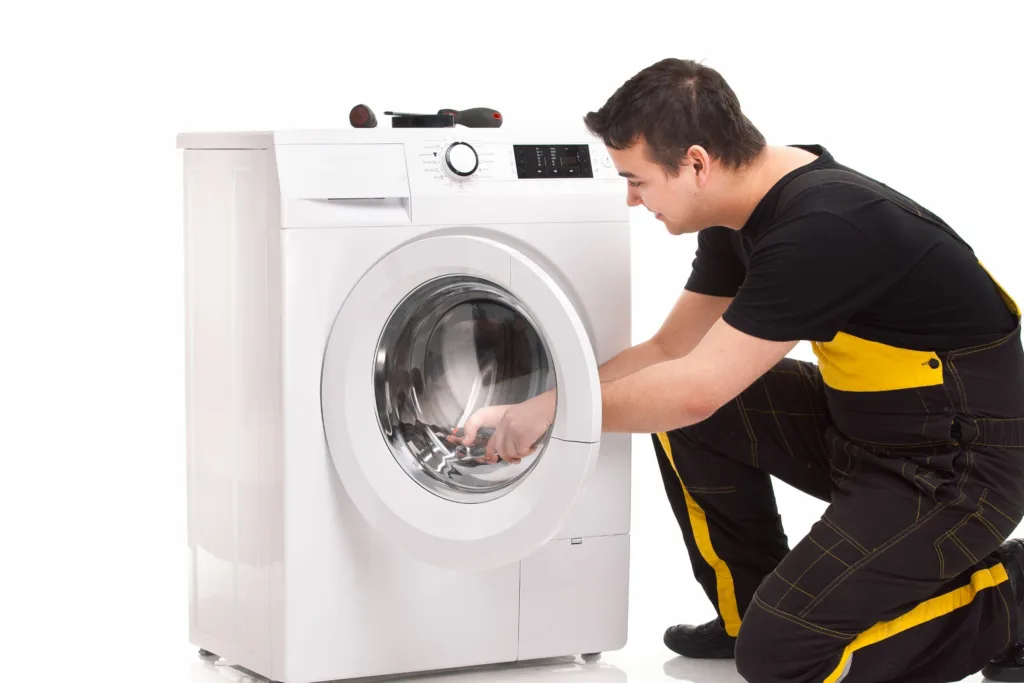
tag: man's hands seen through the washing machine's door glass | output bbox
[452,393,555,465]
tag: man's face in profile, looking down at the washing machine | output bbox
[608,139,707,234]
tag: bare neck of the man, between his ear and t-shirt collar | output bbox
[717,146,817,230]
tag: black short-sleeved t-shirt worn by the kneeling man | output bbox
[686,145,1017,351]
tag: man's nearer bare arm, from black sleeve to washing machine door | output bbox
[602,319,799,433]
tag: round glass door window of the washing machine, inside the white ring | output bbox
[374,275,556,503]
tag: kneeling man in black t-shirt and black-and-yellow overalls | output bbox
[466,59,1024,683]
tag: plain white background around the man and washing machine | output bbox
[0,0,1024,681]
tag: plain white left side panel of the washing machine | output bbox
[184,150,280,671]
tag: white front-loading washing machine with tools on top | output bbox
[177,127,631,683]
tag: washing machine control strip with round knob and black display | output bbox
[417,138,618,188]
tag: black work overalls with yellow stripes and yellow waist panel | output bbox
[653,171,1024,683]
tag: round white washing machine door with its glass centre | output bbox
[321,236,601,569]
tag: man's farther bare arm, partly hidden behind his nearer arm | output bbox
[598,291,732,383]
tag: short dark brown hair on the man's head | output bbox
[584,58,766,175]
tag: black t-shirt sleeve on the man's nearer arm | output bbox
[722,213,902,341]
